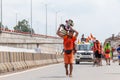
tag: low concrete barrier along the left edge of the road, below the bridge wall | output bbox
[0,52,63,73]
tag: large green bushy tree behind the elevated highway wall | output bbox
[14,19,35,33]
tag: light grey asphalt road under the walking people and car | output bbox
[0,61,120,80]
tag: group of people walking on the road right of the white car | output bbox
[93,40,120,66]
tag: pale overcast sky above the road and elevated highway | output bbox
[0,0,120,42]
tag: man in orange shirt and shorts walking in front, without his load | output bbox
[57,27,78,77]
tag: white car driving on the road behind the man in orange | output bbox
[75,43,94,64]
